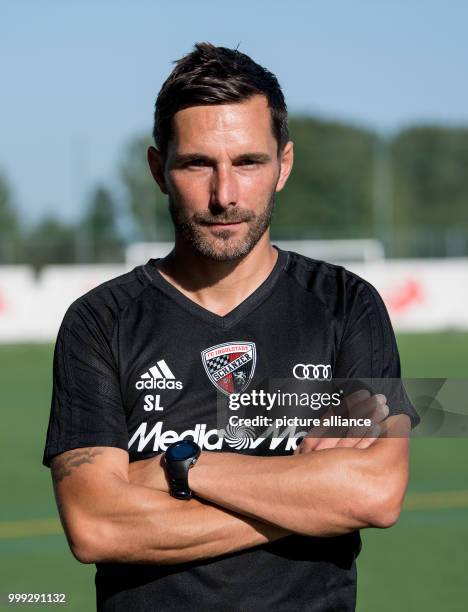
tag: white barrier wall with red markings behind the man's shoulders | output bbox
[0,259,468,342]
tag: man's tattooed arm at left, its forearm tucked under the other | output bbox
[51,447,287,564]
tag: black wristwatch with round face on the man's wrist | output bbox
[164,440,201,499]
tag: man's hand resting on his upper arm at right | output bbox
[294,389,389,455]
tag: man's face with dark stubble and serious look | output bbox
[154,96,292,261]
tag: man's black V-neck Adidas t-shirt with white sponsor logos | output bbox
[43,249,418,612]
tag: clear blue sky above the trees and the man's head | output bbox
[0,0,468,223]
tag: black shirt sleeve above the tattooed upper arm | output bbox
[42,304,128,467]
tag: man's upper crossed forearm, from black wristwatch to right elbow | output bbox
[189,439,407,536]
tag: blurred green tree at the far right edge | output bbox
[392,126,468,256]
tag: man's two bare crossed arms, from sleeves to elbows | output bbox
[52,406,409,564]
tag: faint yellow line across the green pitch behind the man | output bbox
[0,490,468,539]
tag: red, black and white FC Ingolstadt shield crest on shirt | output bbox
[201,342,257,395]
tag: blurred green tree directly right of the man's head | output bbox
[273,117,375,239]
